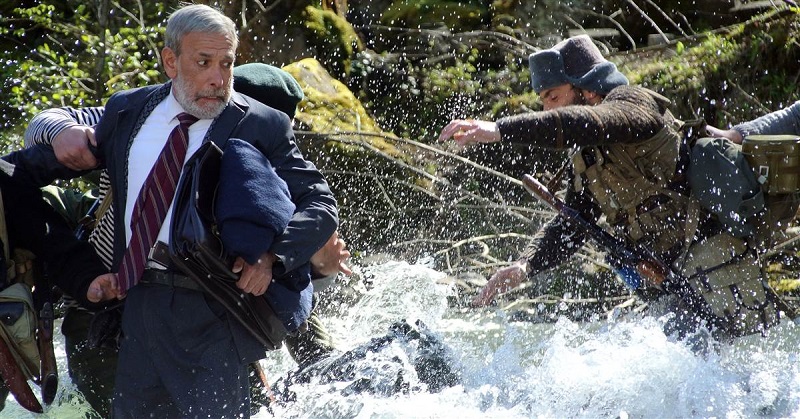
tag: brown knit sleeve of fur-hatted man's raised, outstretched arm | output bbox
[497,86,667,149]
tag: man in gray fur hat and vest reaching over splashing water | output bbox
[440,35,778,348]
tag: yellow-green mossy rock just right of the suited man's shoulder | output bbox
[283,58,435,251]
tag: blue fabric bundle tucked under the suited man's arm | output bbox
[215,138,314,332]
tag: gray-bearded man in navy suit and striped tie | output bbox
[7,5,338,418]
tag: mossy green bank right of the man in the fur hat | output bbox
[623,9,800,127]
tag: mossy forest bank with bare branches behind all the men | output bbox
[0,0,800,314]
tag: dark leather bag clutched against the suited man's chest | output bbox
[169,141,288,350]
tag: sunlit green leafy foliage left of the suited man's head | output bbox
[0,3,164,149]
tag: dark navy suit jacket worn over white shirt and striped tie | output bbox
[10,83,338,278]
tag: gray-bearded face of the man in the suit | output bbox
[162,32,236,119]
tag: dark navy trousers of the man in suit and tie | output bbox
[113,284,250,418]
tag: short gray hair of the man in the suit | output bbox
[164,4,239,55]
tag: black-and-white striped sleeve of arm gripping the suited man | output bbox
[25,106,104,147]
